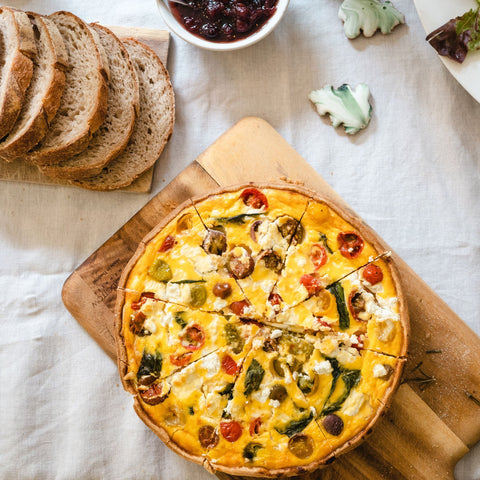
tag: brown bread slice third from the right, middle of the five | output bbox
[26,12,108,165]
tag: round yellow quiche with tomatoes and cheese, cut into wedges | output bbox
[116,184,409,477]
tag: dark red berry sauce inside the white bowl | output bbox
[169,0,278,42]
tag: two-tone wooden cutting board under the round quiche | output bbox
[63,117,480,480]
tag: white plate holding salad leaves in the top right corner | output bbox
[414,0,480,102]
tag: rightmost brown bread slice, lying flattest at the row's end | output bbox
[71,39,175,190]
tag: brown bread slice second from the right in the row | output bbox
[40,24,139,179]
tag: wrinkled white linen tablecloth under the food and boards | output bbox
[0,0,480,480]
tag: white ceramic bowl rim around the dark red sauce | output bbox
[157,0,290,51]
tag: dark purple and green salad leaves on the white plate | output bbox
[426,0,480,63]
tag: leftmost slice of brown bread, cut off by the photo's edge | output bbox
[0,7,37,139]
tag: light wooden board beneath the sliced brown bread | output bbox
[0,26,170,193]
